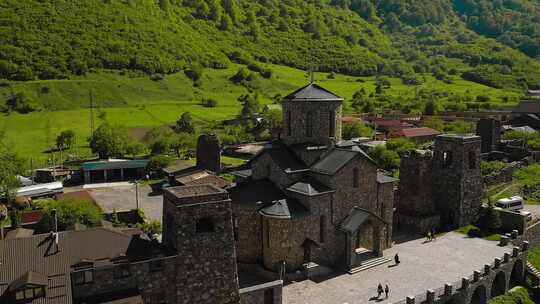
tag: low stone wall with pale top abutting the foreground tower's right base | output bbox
[240,280,283,304]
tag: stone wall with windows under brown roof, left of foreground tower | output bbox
[71,257,176,304]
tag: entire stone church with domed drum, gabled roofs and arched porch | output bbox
[229,83,395,272]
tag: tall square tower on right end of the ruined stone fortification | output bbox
[432,135,482,228]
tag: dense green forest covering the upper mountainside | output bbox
[0,0,540,90]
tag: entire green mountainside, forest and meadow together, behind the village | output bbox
[0,0,540,163]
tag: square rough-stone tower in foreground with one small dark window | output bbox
[163,185,239,304]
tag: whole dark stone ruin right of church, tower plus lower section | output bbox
[397,135,483,233]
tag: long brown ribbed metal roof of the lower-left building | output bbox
[0,228,175,304]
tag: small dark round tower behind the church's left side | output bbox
[197,134,221,174]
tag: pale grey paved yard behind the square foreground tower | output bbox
[86,184,163,221]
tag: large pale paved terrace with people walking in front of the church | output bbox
[283,232,511,304]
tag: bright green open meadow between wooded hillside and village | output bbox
[0,65,517,161]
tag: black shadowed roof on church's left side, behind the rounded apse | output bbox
[228,179,285,207]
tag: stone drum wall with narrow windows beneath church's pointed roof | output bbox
[282,101,342,145]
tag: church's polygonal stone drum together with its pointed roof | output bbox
[282,83,343,146]
